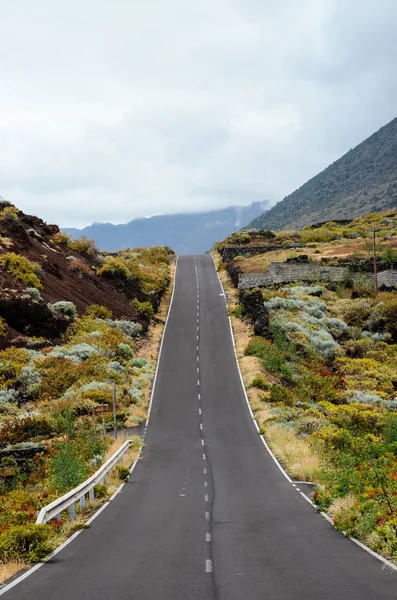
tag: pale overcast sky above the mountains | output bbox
[0,0,397,226]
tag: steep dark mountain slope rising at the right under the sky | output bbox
[248,118,397,230]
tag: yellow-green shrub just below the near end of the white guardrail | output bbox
[0,524,54,562]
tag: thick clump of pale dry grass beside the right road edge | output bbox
[265,423,320,482]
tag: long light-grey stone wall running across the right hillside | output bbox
[238,262,397,290]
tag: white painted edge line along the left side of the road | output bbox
[0,256,179,596]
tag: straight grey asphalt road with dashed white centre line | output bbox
[4,256,397,600]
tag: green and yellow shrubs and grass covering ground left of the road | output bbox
[0,204,174,581]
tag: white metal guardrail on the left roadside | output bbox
[36,440,131,525]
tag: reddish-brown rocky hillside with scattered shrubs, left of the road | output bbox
[0,202,172,348]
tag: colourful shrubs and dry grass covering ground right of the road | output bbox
[216,211,397,561]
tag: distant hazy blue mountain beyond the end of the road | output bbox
[63,202,267,254]
